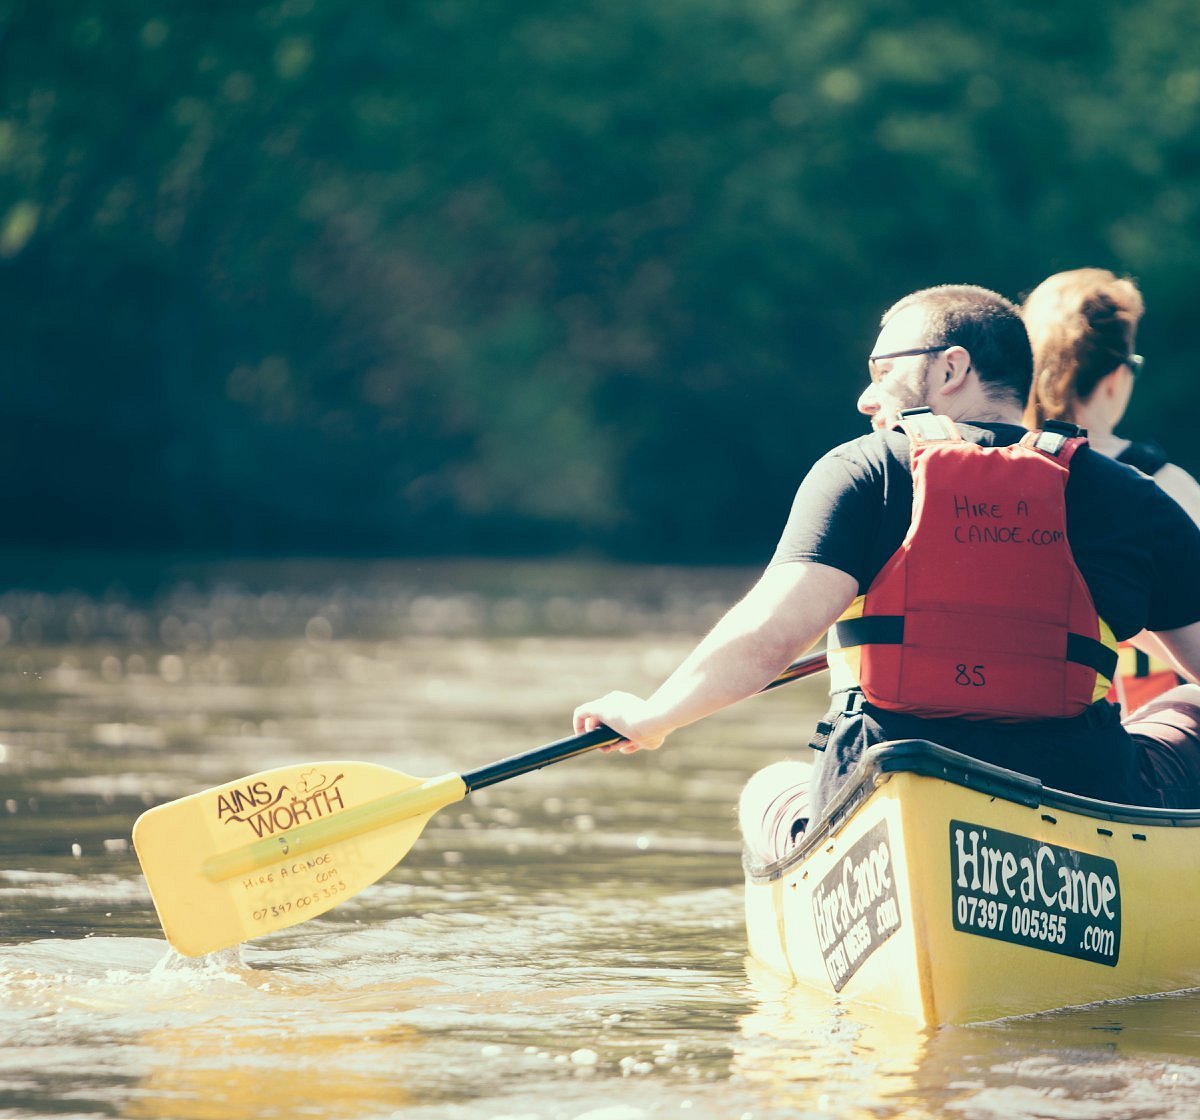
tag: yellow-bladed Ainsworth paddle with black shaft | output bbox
[133,652,828,957]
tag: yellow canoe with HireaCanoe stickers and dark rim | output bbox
[745,741,1200,1026]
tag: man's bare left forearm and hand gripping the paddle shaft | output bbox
[575,561,858,751]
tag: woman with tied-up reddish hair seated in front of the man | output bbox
[1021,269,1200,711]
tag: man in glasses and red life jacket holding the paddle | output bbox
[575,286,1200,855]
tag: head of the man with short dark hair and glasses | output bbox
[858,285,1033,427]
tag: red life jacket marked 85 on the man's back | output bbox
[829,408,1117,723]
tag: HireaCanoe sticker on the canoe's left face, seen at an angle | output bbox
[812,821,900,992]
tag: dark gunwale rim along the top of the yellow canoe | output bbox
[743,739,1200,882]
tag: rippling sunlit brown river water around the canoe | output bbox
[0,563,1200,1120]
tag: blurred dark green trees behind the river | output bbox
[0,0,1200,561]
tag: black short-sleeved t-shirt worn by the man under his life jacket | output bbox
[772,424,1200,639]
